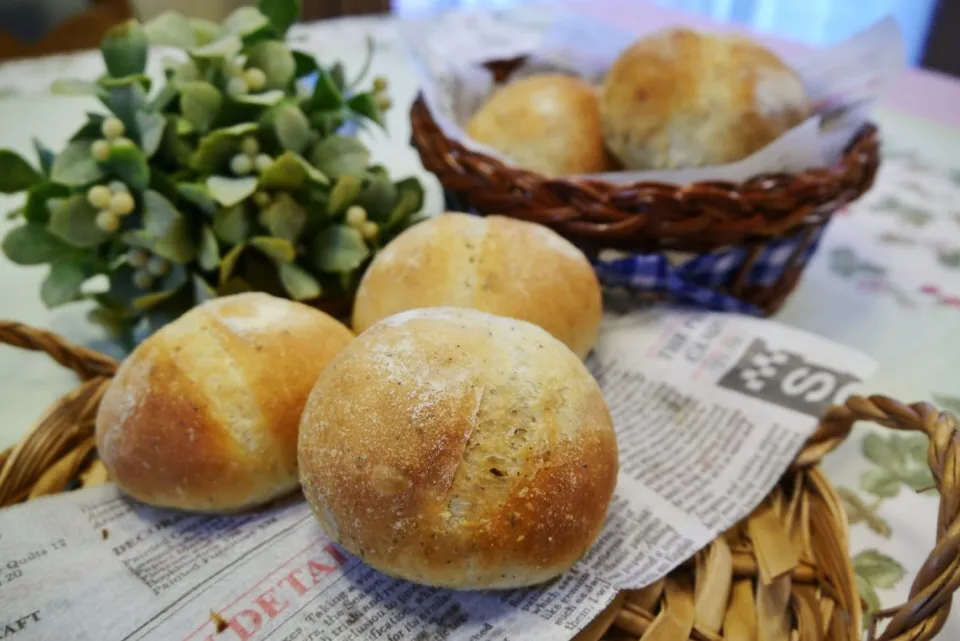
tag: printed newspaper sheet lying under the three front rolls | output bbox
[0,310,874,641]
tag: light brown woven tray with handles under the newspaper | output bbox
[0,322,960,641]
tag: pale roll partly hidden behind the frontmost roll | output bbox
[353,212,603,358]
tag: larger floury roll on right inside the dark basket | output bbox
[600,28,811,170]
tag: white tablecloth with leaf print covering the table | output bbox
[0,1,960,639]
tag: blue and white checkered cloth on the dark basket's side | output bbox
[447,193,823,316]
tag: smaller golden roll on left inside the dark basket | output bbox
[466,73,612,176]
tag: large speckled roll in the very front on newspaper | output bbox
[299,308,618,589]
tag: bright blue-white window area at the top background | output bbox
[393,0,949,65]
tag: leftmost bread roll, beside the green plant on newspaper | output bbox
[96,293,353,512]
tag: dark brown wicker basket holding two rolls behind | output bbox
[410,57,880,315]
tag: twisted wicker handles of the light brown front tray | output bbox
[0,322,960,641]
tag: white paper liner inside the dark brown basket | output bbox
[398,13,906,184]
